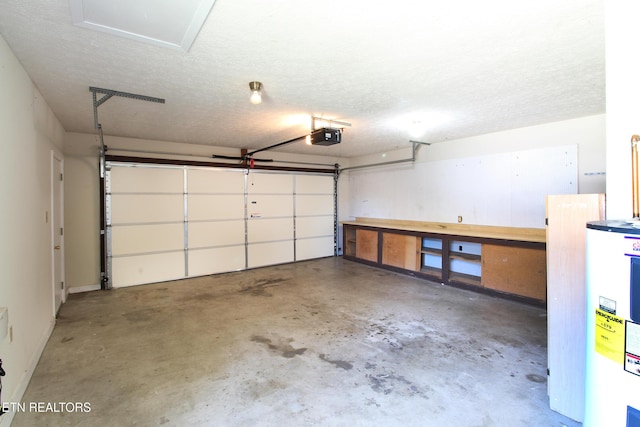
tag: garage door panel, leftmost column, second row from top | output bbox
[111,194,184,224]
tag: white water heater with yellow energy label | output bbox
[584,221,640,427]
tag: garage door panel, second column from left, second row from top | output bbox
[187,194,244,221]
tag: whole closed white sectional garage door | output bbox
[106,162,335,287]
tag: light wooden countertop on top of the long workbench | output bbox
[341,217,547,243]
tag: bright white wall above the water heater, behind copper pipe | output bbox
[605,0,640,219]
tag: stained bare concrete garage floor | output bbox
[12,258,579,427]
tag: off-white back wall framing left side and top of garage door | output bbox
[64,132,345,292]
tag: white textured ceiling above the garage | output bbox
[0,0,605,157]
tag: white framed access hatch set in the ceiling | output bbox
[69,0,215,52]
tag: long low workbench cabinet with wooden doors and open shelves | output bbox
[343,218,546,305]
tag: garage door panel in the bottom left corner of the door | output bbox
[111,251,185,288]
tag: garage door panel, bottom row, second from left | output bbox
[188,245,245,277]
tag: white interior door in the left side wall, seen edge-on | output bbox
[51,152,65,315]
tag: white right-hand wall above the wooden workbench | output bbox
[341,115,605,228]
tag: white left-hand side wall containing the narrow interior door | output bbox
[0,36,64,425]
